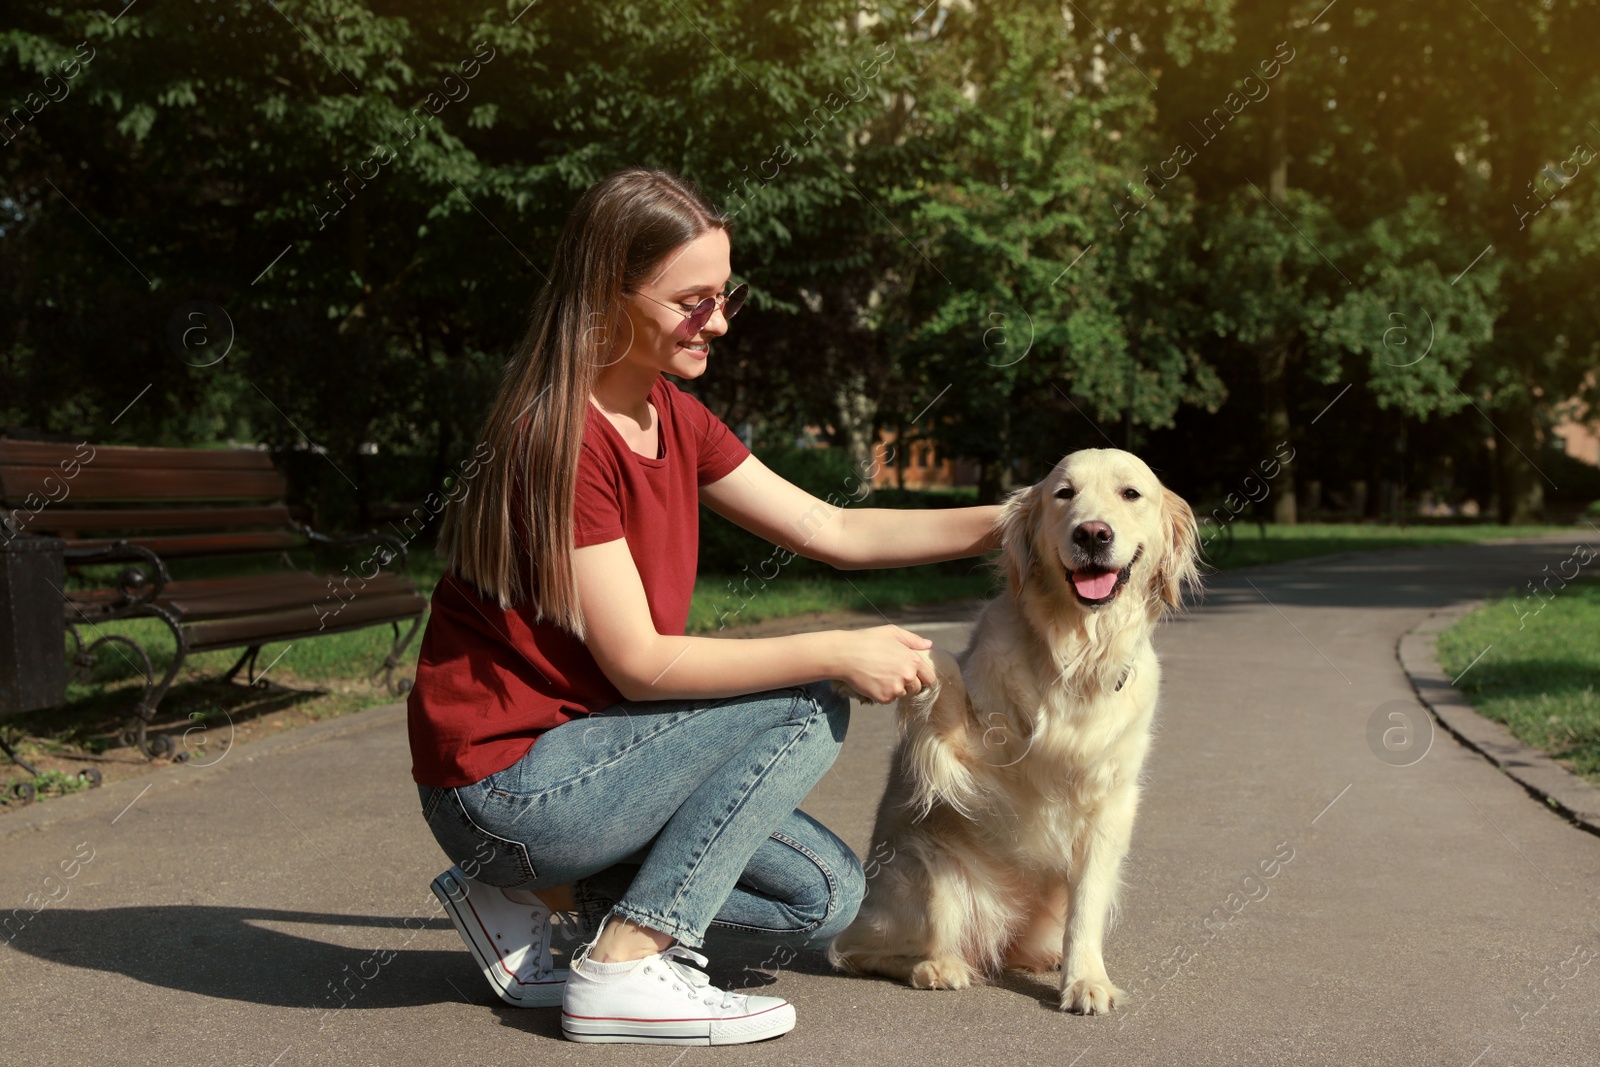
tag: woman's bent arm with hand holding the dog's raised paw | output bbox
[573,537,936,704]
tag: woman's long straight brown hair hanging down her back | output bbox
[438,168,730,640]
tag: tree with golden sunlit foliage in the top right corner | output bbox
[1158,0,1600,522]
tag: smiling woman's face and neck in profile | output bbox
[610,229,733,378]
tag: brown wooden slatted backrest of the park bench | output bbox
[0,438,306,557]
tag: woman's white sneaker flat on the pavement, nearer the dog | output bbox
[562,944,795,1045]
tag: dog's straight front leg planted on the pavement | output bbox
[1061,784,1139,1016]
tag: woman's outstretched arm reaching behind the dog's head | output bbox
[701,456,1000,571]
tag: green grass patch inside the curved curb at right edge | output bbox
[1438,568,1600,785]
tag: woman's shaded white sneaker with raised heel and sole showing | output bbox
[434,867,568,1008]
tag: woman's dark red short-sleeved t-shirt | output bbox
[406,376,750,787]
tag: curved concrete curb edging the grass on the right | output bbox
[1395,600,1600,835]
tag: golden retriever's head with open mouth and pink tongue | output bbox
[1000,448,1200,613]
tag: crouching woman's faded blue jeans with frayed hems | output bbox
[418,681,866,947]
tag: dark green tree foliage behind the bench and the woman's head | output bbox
[0,0,915,518]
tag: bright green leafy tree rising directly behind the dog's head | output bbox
[878,0,1221,501]
